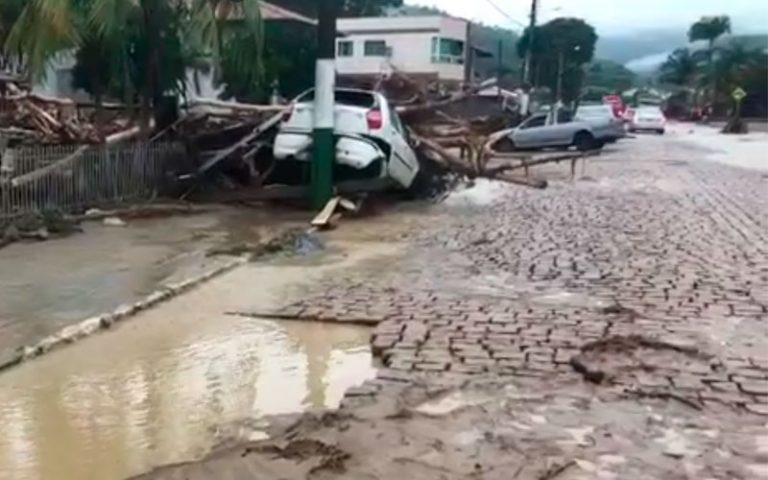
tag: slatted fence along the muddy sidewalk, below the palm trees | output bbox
[0,143,183,219]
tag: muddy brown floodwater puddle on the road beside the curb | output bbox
[0,240,394,480]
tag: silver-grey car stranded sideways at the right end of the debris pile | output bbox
[506,107,623,151]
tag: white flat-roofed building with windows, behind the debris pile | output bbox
[336,16,490,82]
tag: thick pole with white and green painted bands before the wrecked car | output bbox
[310,0,337,209]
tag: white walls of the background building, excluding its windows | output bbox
[336,17,467,81]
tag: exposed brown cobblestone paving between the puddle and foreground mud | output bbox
[264,135,768,415]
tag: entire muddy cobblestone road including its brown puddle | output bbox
[0,127,768,480]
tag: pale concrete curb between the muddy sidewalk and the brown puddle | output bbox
[0,258,248,372]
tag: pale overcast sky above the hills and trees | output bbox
[405,0,768,34]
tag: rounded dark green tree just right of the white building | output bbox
[517,18,597,101]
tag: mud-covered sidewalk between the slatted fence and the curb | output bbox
[0,207,306,365]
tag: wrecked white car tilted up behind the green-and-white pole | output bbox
[273,88,419,188]
